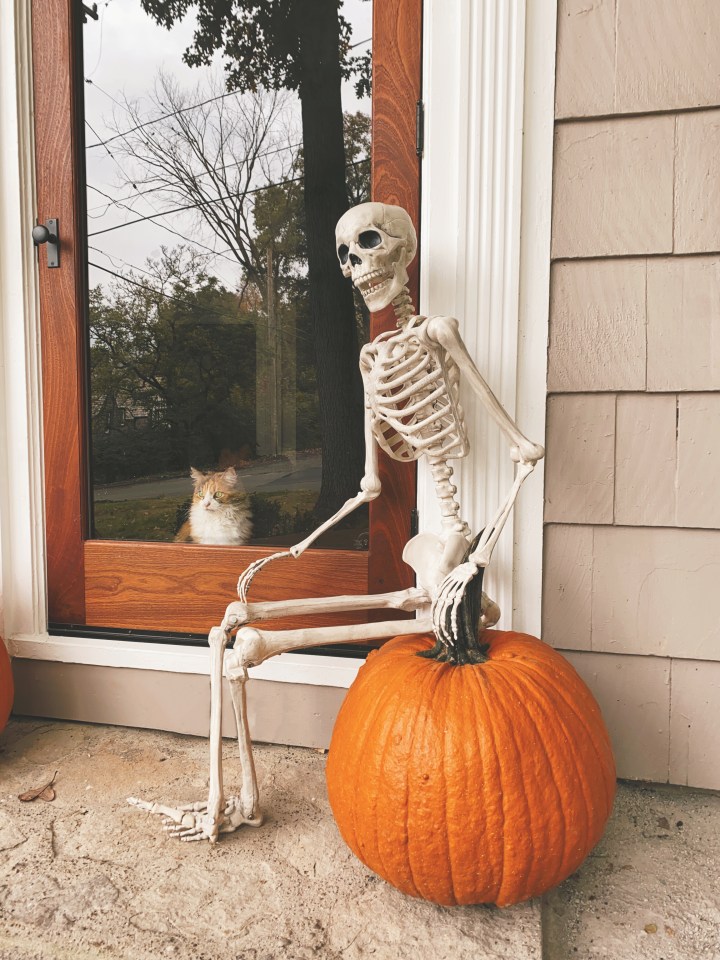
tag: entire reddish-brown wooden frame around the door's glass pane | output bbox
[32,0,422,639]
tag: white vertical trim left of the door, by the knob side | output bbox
[0,0,47,636]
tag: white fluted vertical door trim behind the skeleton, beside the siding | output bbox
[418,0,555,629]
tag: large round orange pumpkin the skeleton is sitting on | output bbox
[327,631,615,906]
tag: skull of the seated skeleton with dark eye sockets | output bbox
[335,203,417,311]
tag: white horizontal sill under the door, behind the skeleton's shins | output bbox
[9,636,365,687]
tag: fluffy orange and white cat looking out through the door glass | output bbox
[175,467,252,546]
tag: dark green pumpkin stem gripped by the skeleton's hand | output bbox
[418,530,490,665]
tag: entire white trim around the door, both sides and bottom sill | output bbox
[0,0,555,687]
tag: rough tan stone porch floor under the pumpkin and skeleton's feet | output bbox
[0,719,720,960]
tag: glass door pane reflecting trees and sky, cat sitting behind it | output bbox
[84,0,371,549]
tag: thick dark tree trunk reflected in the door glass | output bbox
[296,0,364,517]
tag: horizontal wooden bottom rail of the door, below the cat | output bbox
[85,540,372,634]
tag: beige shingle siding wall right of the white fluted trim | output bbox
[543,0,720,788]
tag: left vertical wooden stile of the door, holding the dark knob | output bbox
[33,0,87,623]
